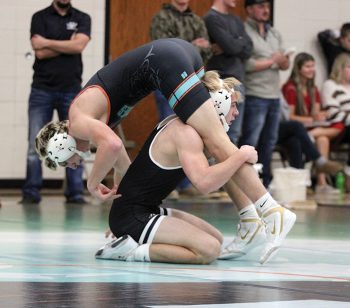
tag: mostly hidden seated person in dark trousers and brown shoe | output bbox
[277,97,343,175]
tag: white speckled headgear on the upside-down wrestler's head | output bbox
[47,133,91,165]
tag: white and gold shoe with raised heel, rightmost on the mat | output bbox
[259,206,297,264]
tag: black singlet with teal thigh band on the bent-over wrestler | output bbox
[82,39,210,127]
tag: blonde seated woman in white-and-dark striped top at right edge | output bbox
[322,53,350,191]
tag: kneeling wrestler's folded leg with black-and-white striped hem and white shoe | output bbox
[102,205,222,264]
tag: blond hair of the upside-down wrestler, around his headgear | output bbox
[35,120,68,170]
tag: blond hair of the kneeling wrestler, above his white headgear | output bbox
[201,71,242,101]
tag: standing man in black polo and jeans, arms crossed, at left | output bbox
[21,0,91,204]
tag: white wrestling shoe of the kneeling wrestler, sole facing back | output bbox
[95,235,139,261]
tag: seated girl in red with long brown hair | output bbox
[282,52,344,193]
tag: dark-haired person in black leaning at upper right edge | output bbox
[318,23,350,74]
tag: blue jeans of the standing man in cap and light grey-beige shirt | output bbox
[240,95,280,187]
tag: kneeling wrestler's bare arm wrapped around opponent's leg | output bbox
[175,125,257,193]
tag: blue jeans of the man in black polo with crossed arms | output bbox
[22,88,84,201]
